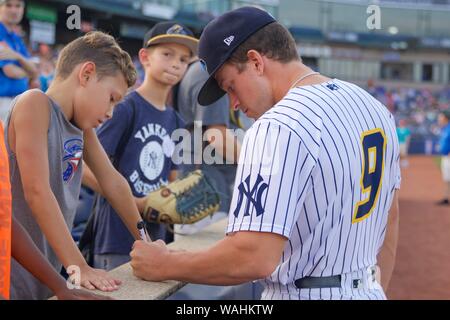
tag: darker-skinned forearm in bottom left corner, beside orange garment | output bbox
[11,218,66,292]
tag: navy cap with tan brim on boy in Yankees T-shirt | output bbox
[144,21,198,56]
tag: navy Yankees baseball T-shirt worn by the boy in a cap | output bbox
[94,91,184,254]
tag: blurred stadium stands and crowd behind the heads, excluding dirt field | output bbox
[26,0,450,154]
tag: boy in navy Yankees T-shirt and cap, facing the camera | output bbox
[84,22,198,270]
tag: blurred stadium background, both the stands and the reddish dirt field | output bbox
[13,0,450,299]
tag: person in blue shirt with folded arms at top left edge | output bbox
[0,0,37,121]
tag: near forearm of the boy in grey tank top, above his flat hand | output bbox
[25,184,86,268]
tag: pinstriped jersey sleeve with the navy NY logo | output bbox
[227,121,317,238]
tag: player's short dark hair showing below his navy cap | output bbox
[228,22,300,72]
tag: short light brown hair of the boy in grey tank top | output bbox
[55,31,137,87]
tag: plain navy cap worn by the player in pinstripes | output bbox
[198,7,276,106]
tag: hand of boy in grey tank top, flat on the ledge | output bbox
[80,266,122,292]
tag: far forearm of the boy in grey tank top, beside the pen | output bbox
[99,171,142,240]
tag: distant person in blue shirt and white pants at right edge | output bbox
[438,110,450,206]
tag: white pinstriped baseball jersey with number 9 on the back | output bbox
[227,79,401,299]
